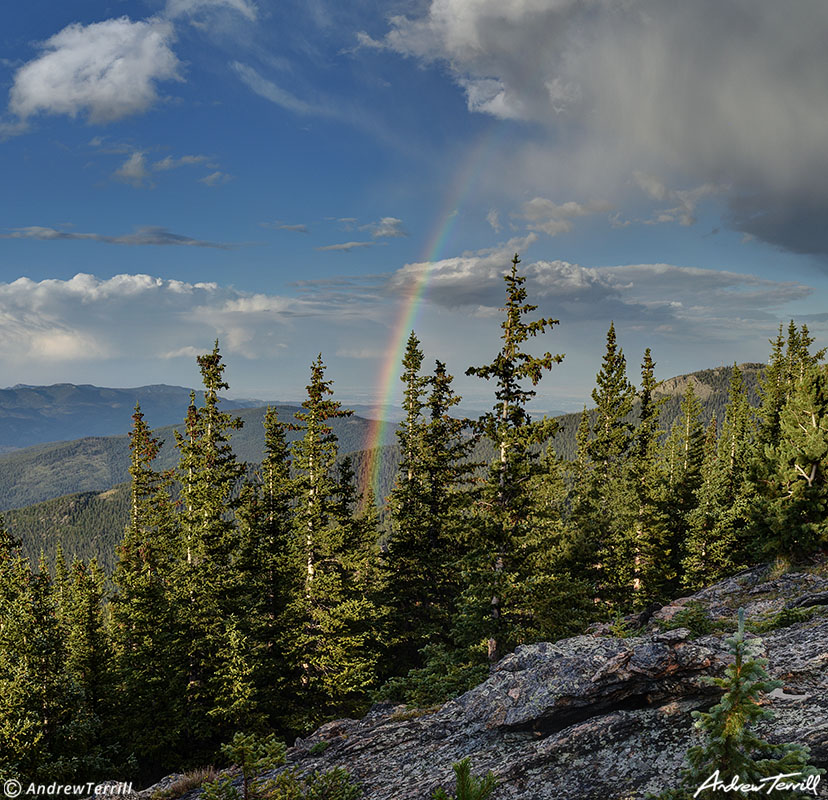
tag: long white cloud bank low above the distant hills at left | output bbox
[0,273,342,363]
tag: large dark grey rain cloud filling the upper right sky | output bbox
[374,0,828,254]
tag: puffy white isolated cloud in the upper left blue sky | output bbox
[9,17,180,123]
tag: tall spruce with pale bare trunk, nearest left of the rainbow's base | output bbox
[284,354,377,728]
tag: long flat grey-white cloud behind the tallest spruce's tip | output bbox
[388,240,812,340]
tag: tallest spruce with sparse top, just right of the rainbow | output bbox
[465,254,563,661]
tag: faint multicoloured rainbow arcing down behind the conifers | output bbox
[362,124,496,502]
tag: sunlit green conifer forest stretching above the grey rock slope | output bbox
[0,256,828,796]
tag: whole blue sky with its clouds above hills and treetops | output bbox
[0,0,828,410]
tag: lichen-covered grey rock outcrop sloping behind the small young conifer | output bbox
[280,569,828,800]
